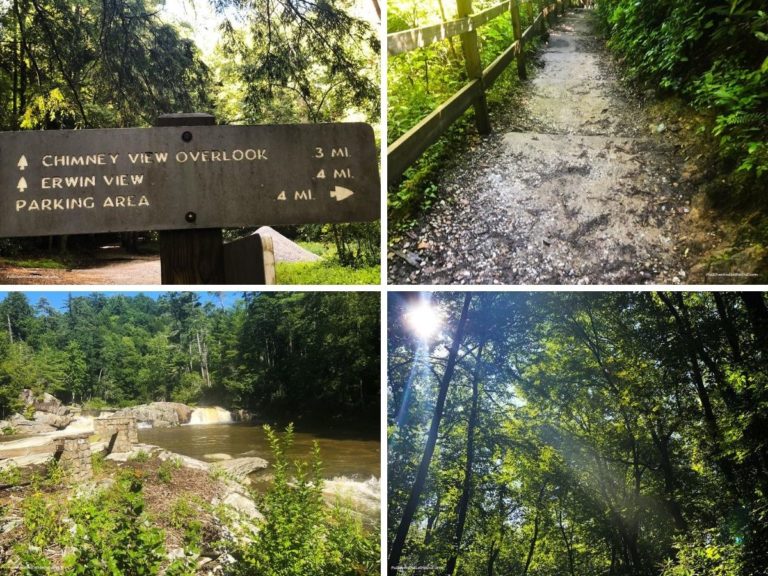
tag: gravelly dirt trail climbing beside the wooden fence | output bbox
[389,11,704,284]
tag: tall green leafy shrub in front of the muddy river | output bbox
[233,425,380,576]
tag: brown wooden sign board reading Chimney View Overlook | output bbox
[0,123,380,237]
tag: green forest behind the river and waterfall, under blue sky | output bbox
[0,292,380,431]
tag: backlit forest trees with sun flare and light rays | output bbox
[388,292,768,576]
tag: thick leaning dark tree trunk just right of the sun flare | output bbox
[387,292,472,576]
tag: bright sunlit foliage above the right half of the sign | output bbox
[214,0,380,123]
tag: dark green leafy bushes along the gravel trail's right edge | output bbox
[598,0,768,188]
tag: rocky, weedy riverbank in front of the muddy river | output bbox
[0,444,379,575]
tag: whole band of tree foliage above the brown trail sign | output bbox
[0,0,379,130]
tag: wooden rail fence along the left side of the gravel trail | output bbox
[387,0,573,186]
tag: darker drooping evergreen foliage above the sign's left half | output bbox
[0,0,209,130]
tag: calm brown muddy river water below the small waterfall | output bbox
[139,424,381,481]
